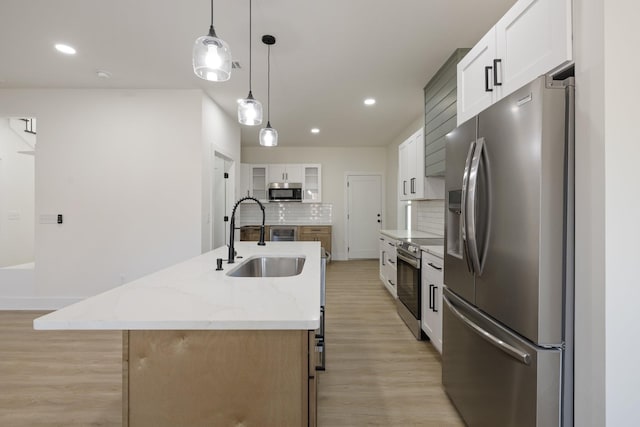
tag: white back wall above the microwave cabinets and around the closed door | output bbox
[242,147,384,260]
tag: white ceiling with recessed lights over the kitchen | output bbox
[0,0,515,146]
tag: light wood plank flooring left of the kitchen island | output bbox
[0,311,122,427]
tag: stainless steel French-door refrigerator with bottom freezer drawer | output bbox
[442,77,574,427]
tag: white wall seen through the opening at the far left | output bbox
[0,118,35,268]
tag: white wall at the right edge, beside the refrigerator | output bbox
[574,0,640,427]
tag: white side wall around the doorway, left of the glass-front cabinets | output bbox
[201,95,240,252]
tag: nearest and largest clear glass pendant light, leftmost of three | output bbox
[193,0,231,82]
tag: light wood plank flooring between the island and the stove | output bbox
[318,260,464,427]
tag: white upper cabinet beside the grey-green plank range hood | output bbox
[398,129,444,200]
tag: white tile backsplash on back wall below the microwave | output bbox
[239,202,333,225]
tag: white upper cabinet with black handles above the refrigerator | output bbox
[458,0,573,125]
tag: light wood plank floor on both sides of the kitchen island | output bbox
[0,260,464,427]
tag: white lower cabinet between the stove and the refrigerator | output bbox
[420,251,444,354]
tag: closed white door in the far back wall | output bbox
[347,175,382,259]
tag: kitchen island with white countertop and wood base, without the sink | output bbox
[34,242,321,427]
